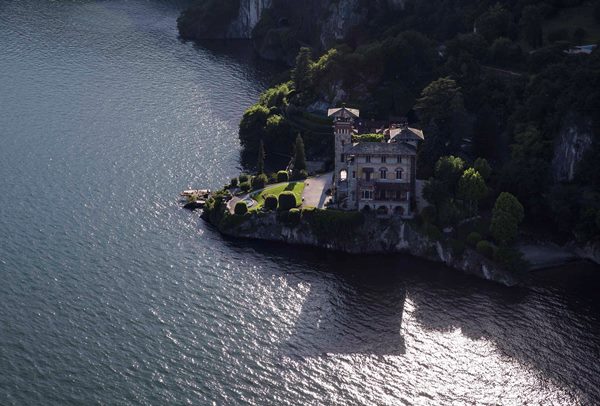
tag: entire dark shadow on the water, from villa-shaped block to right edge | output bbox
[218,235,600,404]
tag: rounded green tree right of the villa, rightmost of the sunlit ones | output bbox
[490,192,524,245]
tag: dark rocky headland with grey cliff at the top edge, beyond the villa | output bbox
[178,0,405,63]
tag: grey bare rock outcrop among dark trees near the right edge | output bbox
[552,114,594,182]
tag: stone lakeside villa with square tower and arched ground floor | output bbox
[328,107,423,218]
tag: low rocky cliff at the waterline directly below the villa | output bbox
[212,212,518,286]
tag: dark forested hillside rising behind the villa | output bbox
[179,0,600,241]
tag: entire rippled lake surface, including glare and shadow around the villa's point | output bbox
[0,0,600,405]
